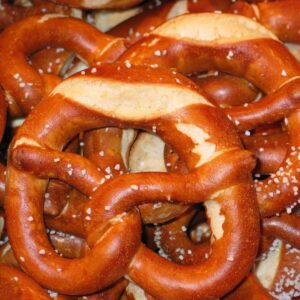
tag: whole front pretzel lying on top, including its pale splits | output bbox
[5,64,259,299]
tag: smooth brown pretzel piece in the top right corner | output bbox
[229,0,300,43]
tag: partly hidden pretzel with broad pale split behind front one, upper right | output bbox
[120,14,300,216]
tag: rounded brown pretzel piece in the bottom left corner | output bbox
[0,264,51,300]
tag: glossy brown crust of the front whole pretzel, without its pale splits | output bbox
[5,64,259,299]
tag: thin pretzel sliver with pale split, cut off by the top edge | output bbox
[49,0,143,9]
